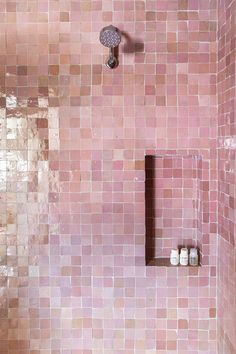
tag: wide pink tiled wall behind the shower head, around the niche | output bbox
[0,0,217,354]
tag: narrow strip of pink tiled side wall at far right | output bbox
[218,0,236,354]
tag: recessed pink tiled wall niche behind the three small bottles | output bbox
[145,154,202,265]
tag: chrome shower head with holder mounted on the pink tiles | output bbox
[99,25,121,69]
